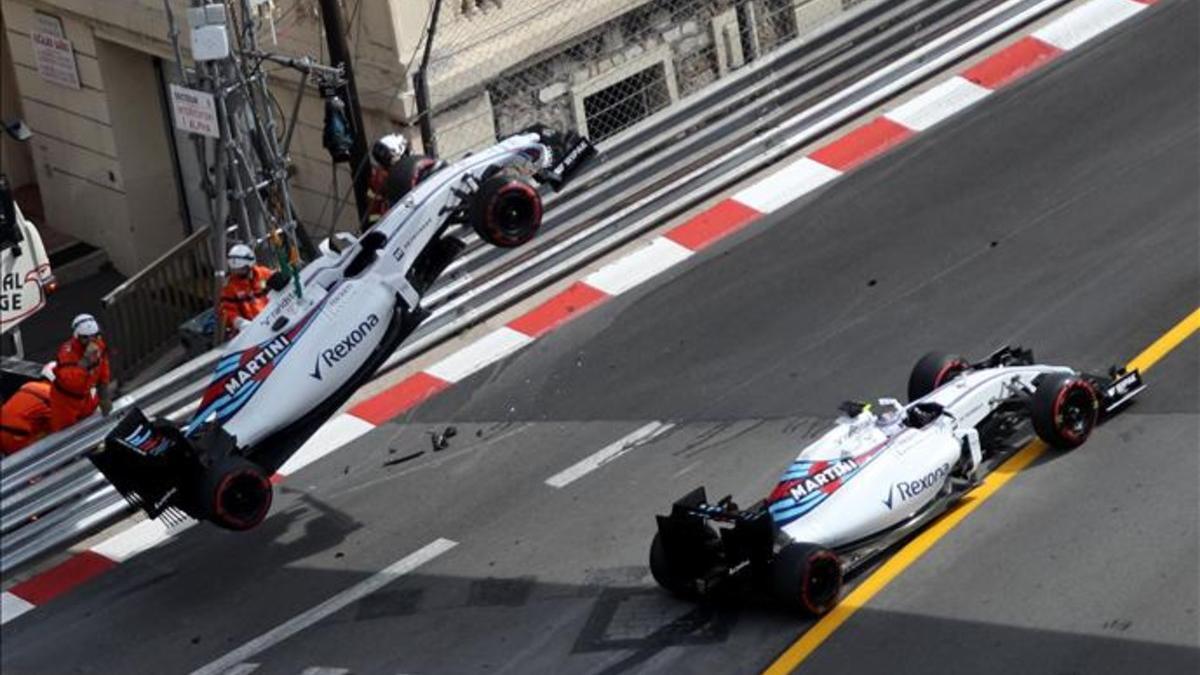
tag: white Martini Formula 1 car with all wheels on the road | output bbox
[650,347,1145,615]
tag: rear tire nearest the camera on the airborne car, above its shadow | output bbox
[198,456,274,532]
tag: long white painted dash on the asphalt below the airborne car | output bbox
[192,539,457,675]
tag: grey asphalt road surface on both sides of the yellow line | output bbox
[0,0,1200,675]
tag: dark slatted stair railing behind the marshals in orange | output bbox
[101,226,216,380]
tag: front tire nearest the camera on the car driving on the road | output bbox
[1030,372,1100,450]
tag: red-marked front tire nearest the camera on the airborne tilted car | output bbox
[469,172,542,249]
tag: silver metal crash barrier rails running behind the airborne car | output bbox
[0,0,1070,572]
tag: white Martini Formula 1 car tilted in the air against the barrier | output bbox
[91,127,594,530]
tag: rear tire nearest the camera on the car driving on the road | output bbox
[770,543,842,616]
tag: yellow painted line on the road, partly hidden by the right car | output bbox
[763,307,1200,675]
